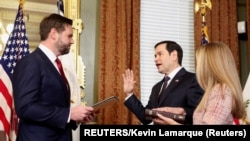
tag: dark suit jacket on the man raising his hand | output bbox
[124,68,203,124]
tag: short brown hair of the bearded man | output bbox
[40,13,73,41]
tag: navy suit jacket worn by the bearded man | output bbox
[12,48,77,141]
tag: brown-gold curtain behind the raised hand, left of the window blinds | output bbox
[97,0,140,124]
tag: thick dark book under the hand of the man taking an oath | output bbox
[145,109,185,123]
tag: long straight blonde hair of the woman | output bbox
[196,42,245,118]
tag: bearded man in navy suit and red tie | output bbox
[12,14,94,141]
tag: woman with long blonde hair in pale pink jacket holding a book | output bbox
[154,42,245,124]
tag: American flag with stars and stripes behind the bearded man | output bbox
[0,3,29,141]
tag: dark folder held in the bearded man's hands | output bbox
[92,96,119,112]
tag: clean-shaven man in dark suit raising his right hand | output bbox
[123,41,203,124]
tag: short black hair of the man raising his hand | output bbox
[155,40,183,65]
